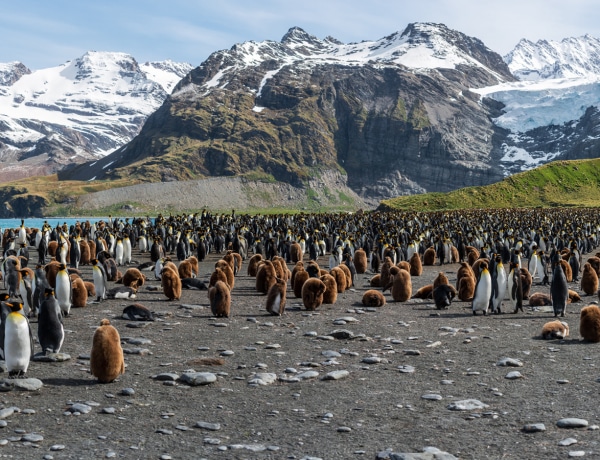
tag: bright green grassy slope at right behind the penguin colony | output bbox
[380,159,600,211]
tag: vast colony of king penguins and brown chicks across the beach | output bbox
[0,210,600,382]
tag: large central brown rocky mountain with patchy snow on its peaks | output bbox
[59,24,513,200]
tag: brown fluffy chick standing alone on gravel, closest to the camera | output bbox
[90,319,125,383]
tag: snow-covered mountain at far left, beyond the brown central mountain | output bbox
[0,51,192,182]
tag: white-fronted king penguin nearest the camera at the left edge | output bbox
[4,302,33,377]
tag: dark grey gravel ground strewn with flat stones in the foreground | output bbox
[0,244,600,459]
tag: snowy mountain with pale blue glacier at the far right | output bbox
[474,35,600,176]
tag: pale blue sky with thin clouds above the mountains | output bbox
[0,0,600,70]
